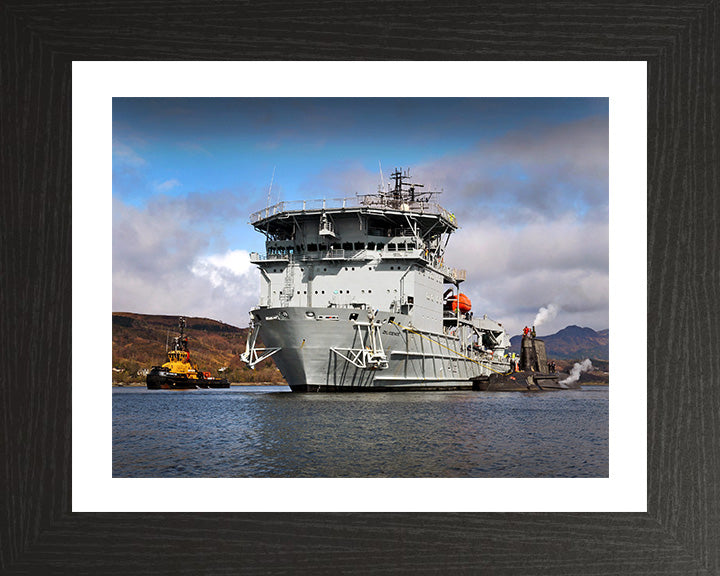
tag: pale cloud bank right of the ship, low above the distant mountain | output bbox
[445,213,609,334]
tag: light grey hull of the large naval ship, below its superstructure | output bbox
[254,307,509,392]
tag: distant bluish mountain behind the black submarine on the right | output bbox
[510,326,610,360]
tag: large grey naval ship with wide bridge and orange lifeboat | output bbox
[241,169,514,392]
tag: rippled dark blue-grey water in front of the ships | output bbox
[113,386,608,478]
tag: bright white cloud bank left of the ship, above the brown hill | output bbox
[113,199,260,326]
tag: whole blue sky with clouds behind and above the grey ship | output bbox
[112,98,609,335]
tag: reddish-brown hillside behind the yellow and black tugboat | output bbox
[112,312,284,383]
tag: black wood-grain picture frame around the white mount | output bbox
[0,0,720,575]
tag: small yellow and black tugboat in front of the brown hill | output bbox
[145,318,230,390]
